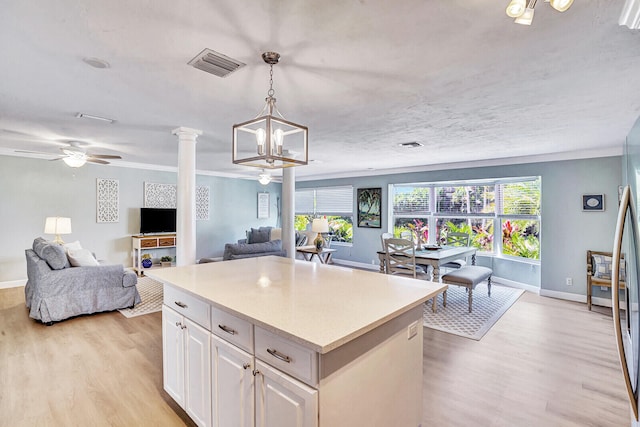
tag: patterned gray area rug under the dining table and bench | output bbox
[424,282,524,341]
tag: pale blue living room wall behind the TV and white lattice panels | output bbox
[0,156,281,282]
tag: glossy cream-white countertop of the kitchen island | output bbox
[145,256,446,353]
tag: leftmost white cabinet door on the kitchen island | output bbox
[162,305,184,408]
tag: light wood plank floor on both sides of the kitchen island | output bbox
[0,288,629,427]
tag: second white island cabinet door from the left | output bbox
[184,318,211,426]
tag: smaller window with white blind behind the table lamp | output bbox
[294,186,353,243]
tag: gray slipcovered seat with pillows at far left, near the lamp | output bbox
[24,238,140,324]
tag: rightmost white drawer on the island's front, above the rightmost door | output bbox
[255,326,318,387]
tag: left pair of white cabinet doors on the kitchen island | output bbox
[162,304,211,426]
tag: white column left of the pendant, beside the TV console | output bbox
[171,127,202,265]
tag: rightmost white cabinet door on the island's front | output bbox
[256,360,318,427]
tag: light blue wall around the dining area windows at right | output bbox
[296,156,622,295]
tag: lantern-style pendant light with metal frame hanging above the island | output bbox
[232,52,309,169]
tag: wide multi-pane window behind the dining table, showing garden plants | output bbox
[389,177,541,260]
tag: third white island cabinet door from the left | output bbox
[211,335,255,427]
